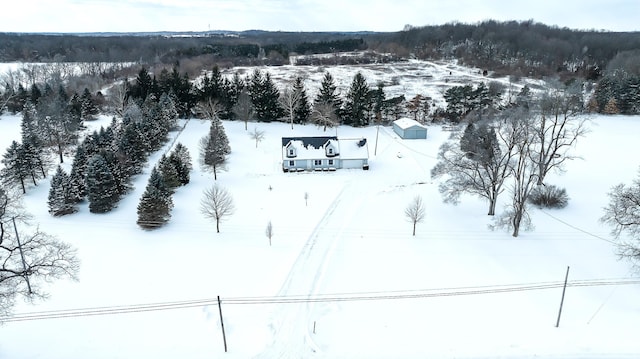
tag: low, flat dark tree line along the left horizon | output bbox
[0,31,366,65]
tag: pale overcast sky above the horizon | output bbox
[5,0,640,32]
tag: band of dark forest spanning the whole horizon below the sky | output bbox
[0,21,640,79]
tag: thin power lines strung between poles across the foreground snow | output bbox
[0,278,640,322]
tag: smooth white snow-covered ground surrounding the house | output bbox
[0,60,640,359]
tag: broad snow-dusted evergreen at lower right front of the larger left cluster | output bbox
[85,155,119,213]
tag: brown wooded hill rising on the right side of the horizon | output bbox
[372,20,640,79]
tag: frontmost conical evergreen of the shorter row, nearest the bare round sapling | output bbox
[137,167,173,229]
